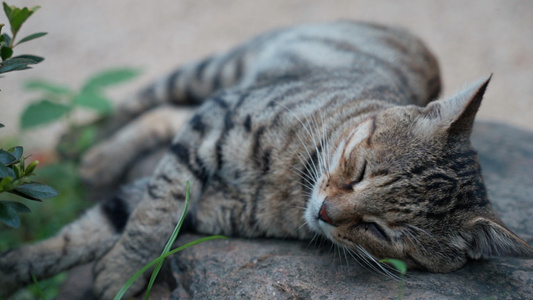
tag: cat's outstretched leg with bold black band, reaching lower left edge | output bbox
[0,179,148,297]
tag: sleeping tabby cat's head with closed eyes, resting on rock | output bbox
[305,77,533,272]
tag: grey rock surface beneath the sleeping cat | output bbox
[58,122,533,299]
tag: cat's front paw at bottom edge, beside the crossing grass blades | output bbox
[93,247,147,299]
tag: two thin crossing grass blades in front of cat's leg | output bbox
[113,181,227,300]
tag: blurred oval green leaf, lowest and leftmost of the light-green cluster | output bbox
[20,100,71,129]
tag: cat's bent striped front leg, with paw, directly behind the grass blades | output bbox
[93,151,204,299]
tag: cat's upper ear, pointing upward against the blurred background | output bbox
[423,74,492,136]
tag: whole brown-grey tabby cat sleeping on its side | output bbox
[0,21,533,299]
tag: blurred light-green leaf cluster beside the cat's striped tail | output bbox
[20,68,139,129]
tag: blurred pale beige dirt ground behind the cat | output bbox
[0,0,533,150]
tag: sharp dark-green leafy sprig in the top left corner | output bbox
[0,2,47,73]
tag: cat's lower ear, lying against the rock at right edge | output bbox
[468,217,533,259]
